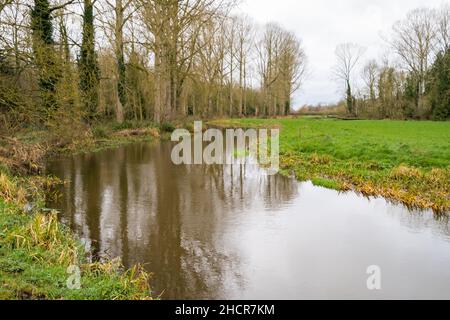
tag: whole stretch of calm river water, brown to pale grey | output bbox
[48,141,450,299]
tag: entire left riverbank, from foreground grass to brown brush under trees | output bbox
[0,123,162,300]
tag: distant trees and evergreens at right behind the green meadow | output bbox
[334,4,450,120]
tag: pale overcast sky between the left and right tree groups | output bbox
[240,0,445,107]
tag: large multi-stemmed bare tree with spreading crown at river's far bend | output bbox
[142,0,235,122]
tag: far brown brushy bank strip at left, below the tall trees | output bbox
[0,122,163,174]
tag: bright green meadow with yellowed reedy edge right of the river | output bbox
[210,117,450,212]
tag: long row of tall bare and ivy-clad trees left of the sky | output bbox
[0,0,306,131]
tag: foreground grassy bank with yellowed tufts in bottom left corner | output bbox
[0,173,151,299]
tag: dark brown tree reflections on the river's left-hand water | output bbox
[48,142,298,298]
